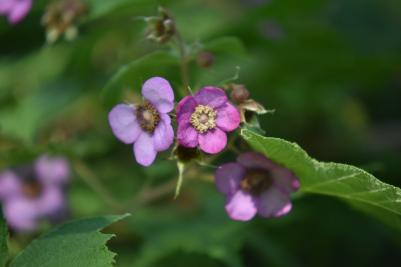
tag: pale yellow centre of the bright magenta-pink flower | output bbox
[191,105,217,133]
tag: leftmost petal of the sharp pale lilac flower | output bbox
[109,104,142,144]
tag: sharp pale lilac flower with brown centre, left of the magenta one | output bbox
[109,77,174,166]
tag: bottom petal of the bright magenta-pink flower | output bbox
[198,128,227,154]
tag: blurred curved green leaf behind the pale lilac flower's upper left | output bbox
[102,51,179,107]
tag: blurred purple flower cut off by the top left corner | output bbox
[0,0,32,24]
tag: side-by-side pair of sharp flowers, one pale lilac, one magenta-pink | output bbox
[109,77,240,166]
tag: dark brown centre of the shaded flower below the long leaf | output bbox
[240,169,273,196]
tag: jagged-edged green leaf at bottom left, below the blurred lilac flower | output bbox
[10,215,128,267]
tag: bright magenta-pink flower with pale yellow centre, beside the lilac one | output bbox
[177,86,240,154]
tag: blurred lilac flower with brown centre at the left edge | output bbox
[0,156,69,231]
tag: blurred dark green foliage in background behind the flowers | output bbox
[0,0,401,266]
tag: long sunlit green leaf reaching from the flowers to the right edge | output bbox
[241,129,401,229]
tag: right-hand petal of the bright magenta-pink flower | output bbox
[216,102,241,132]
